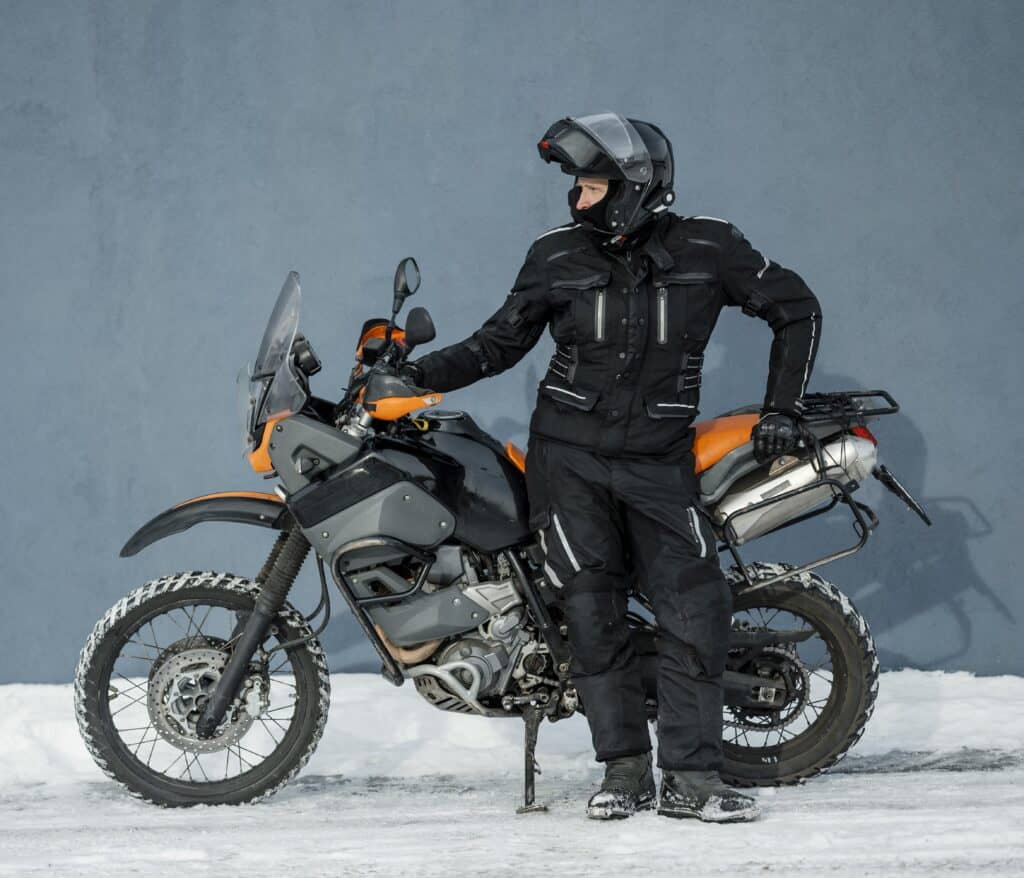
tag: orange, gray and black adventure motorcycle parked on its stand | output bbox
[75,259,931,811]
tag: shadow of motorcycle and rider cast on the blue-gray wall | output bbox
[325,364,1016,671]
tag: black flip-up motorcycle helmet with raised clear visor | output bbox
[537,113,676,236]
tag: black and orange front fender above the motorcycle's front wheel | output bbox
[121,491,292,558]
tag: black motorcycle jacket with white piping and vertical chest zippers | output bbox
[416,212,821,460]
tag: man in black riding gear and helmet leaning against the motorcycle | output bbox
[409,113,821,822]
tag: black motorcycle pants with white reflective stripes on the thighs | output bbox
[526,436,732,770]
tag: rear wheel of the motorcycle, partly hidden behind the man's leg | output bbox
[722,562,879,786]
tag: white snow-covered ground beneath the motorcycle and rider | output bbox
[0,671,1024,878]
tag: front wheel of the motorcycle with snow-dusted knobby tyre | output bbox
[75,573,331,806]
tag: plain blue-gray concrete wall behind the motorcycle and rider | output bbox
[0,0,1024,681]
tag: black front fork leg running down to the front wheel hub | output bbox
[196,527,309,738]
